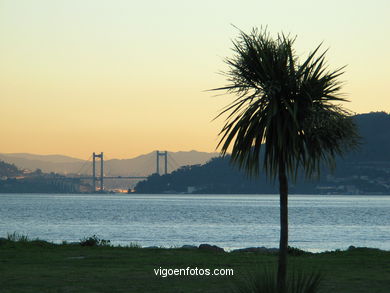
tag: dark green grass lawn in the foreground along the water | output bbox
[0,237,390,293]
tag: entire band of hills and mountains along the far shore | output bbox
[0,112,390,194]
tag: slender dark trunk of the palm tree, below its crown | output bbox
[277,159,288,293]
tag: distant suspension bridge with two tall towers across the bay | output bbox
[66,151,178,192]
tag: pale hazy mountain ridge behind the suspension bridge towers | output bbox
[0,151,218,176]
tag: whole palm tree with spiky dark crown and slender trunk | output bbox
[213,29,358,293]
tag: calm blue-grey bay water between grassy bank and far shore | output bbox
[0,194,390,251]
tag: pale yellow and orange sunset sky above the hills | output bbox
[0,0,390,159]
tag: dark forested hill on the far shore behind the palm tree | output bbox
[135,112,390,194]
